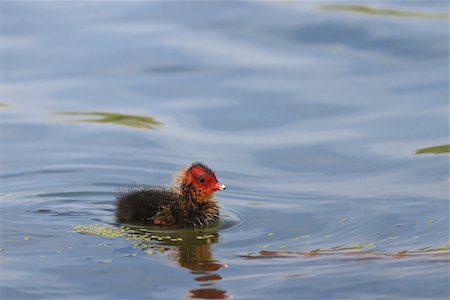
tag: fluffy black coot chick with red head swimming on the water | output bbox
[116,163,225,227]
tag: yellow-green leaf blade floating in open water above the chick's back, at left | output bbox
[54,112,162,129]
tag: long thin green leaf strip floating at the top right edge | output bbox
[320,4,450,19]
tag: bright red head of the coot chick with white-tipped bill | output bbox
[182,163,225,202]
